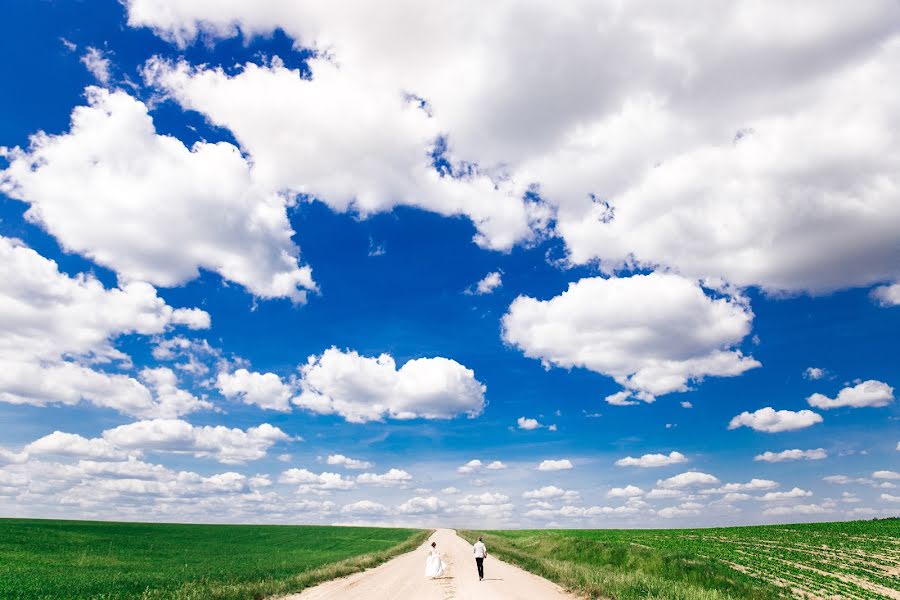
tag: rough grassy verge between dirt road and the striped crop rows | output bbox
[458,531,789,600]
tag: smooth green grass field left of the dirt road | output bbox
[0,519,429,600]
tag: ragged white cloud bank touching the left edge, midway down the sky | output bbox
[0,237,212,417]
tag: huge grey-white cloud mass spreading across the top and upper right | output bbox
[127,0,900,292]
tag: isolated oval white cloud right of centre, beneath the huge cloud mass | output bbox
[503,273,759,405]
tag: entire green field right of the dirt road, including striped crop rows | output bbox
[459,519,900,600]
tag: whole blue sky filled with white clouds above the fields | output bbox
[0,0,900,527]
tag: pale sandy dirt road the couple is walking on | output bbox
[285,529,575,600]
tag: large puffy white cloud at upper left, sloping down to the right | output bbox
[0,87,316,302]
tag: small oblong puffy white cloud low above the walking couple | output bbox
[293,348,486,423]
